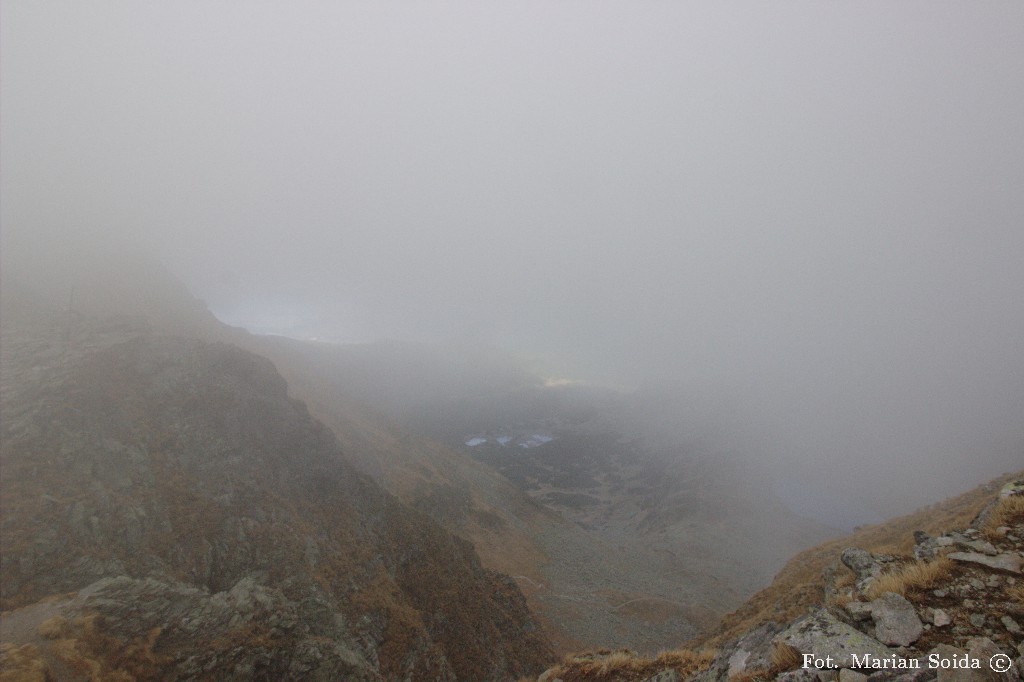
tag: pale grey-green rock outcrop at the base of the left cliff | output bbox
[68,577,380,682]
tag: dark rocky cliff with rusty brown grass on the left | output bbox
[0,316,550,680]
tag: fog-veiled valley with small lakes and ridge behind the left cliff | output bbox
[4,256,831,651]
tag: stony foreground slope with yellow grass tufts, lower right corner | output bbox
[538,474,1024,682]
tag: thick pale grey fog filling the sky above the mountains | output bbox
[0,0,1024,509]
